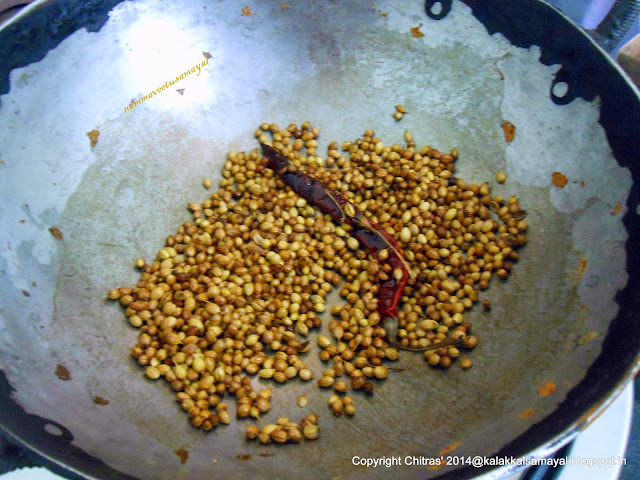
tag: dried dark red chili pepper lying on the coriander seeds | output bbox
[260,144,409,319]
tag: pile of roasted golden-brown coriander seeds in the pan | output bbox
[108,122,527,436]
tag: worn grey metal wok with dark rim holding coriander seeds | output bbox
[0,0,640,479]
